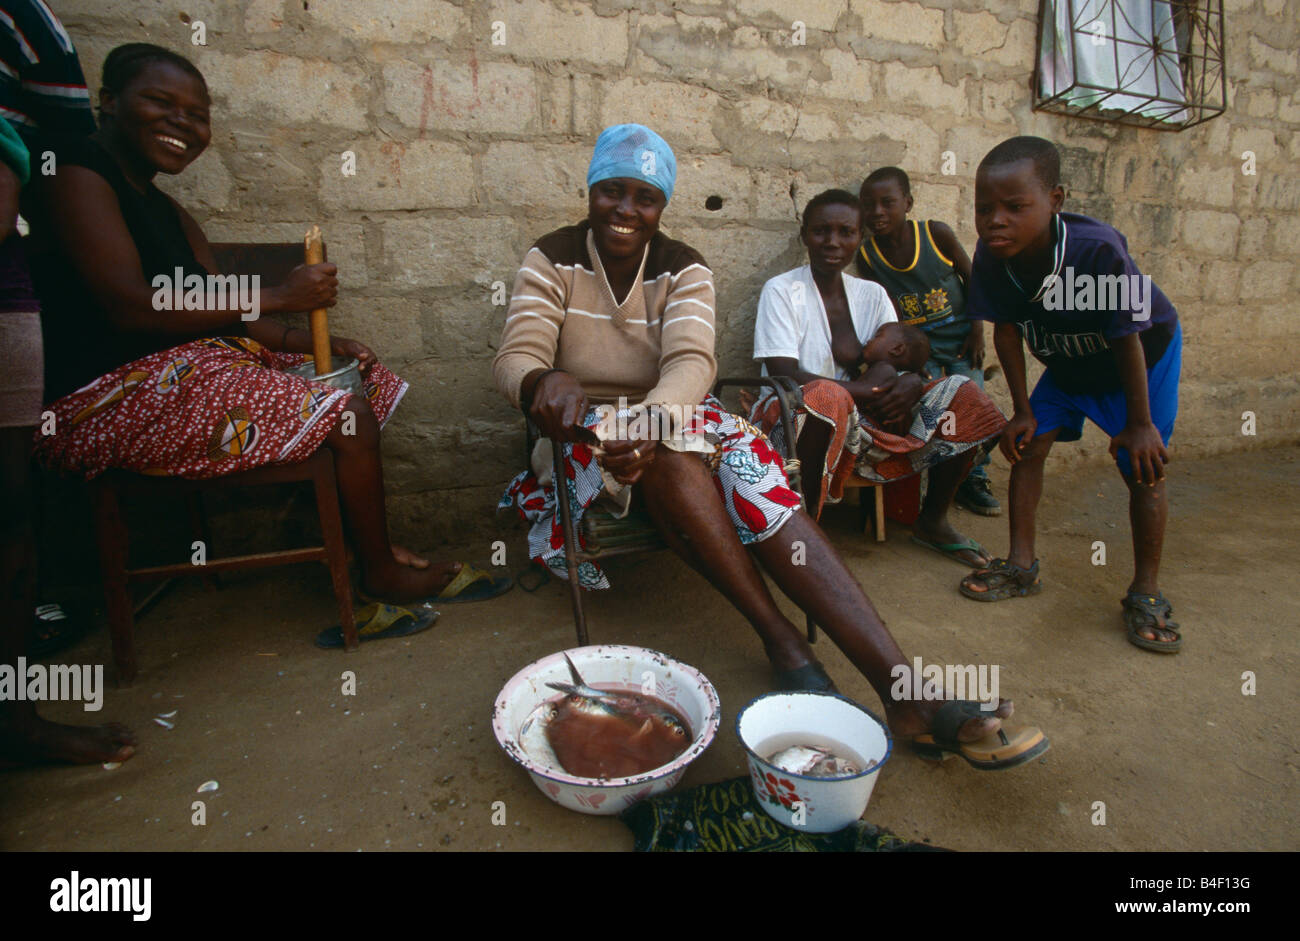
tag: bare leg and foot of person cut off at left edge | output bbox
[0,428,137,768]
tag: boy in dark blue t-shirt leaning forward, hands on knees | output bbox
[961,136,1183,654]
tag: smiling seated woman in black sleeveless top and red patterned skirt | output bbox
[33,43,510,618]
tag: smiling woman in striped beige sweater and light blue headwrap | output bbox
[493,125,1047,767]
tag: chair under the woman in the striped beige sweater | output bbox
[546,376,816,647]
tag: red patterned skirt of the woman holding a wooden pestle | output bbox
[36,337,407,480]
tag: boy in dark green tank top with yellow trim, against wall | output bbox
[854,166,1002,516]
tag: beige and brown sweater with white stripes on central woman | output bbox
[493,222,718,412]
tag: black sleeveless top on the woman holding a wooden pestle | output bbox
[31,139,247,402]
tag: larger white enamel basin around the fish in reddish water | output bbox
[491,643,722,815]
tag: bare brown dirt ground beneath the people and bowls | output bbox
[0,448,1300,851]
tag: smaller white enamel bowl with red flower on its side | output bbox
[736,691,893,833]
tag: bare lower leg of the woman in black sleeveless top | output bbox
[325,395,460,602]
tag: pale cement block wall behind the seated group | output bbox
[51,0,1300,545]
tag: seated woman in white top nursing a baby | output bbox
[753,190,1006,565]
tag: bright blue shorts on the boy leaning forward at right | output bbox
[1030,324,1183,477]
